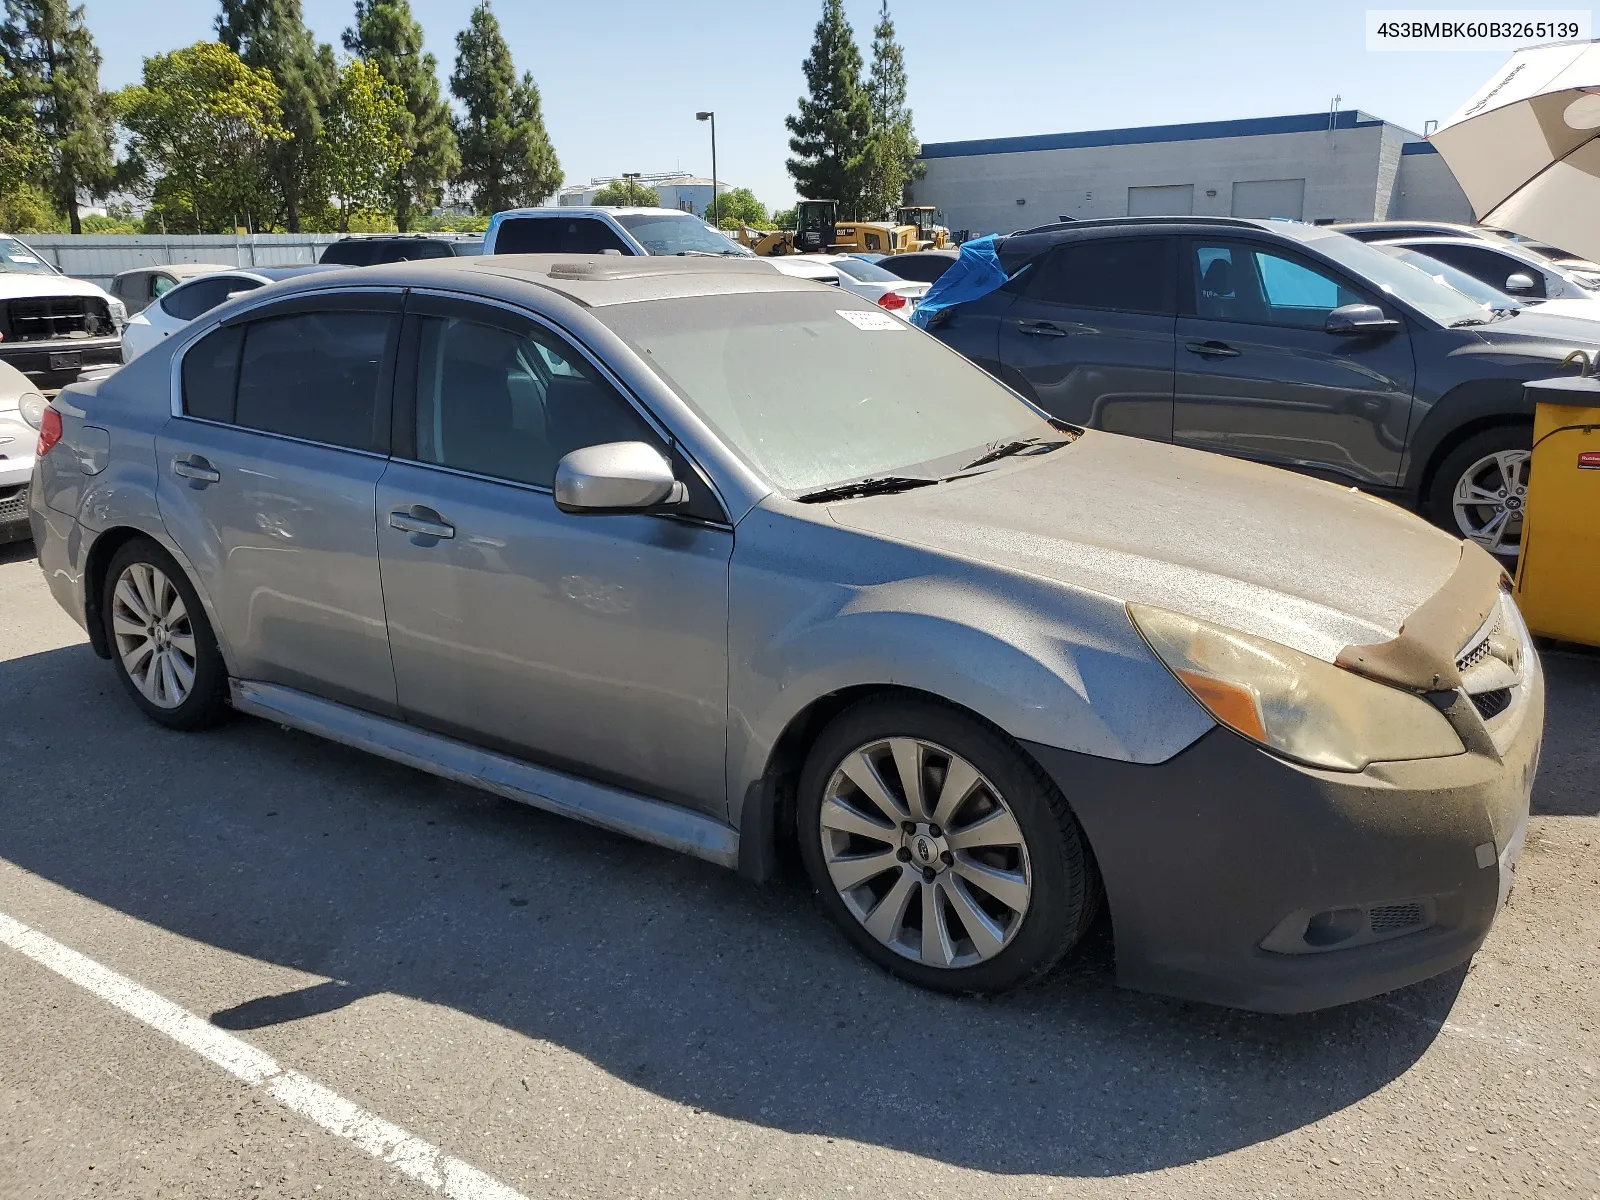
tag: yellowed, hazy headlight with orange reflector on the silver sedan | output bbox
[1128,605,1466,771]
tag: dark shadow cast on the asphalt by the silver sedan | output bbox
[0,645,1600,1178]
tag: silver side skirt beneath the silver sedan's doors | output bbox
[229,680,739,869]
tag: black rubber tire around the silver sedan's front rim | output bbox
[795,698,1098,994]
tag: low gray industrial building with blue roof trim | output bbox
[914,109,1472,235]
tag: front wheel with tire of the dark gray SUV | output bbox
[1429,426,1533,563]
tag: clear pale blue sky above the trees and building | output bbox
[75,0,1534,206]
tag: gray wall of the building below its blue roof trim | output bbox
[914,125,1387,235]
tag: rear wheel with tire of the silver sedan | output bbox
[101,538,227,730]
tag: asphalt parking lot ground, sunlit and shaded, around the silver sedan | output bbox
[0,546,1600,1200]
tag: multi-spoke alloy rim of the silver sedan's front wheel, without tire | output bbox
[818,738,1034,968]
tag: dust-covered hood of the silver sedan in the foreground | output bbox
[830,432,1494,662]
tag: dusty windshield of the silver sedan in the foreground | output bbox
[602,290,1059,491]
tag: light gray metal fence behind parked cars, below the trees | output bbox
[21,234,339,288]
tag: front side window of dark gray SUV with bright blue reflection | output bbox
[1194,243,1371,330]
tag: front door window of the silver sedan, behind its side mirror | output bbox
[416,317,658,488]
